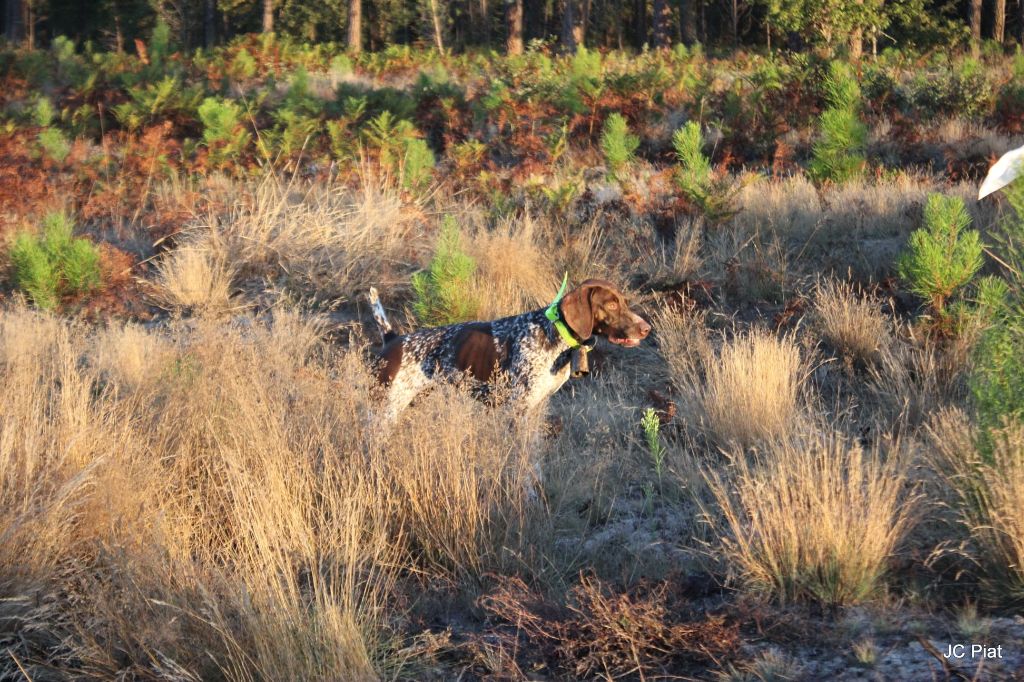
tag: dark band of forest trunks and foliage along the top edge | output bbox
[0,0,1024,56]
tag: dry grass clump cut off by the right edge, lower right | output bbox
[929,411,1024,608]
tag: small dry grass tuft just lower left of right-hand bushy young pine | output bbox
[814,281,889,366]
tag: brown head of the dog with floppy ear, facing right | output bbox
[561,280,650,348]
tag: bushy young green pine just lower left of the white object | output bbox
[897,195,982,322]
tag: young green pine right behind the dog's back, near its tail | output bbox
[413,215,480,326]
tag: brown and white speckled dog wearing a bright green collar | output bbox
[371,280,650,421]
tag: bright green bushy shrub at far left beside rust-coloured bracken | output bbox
[10,213,100,309]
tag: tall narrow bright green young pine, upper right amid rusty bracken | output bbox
[808,61,867,182]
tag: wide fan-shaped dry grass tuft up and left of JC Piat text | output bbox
[706,433,915,604]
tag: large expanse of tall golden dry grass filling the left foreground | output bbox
[0,309,543,680]
